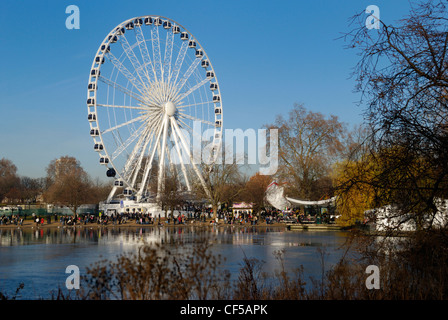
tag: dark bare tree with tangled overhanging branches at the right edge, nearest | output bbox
[346,1,448,230]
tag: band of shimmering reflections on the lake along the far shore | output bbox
[0,226,344,247]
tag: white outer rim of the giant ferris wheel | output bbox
[87,15,223,200]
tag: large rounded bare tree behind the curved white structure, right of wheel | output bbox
[267,104,347,200]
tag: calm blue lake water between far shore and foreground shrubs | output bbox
[0,226,347,300]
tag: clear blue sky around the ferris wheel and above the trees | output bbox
[0,0,409,179]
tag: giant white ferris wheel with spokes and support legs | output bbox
[87,15,223,202]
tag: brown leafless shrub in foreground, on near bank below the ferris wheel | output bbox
[77,238,230,300]
